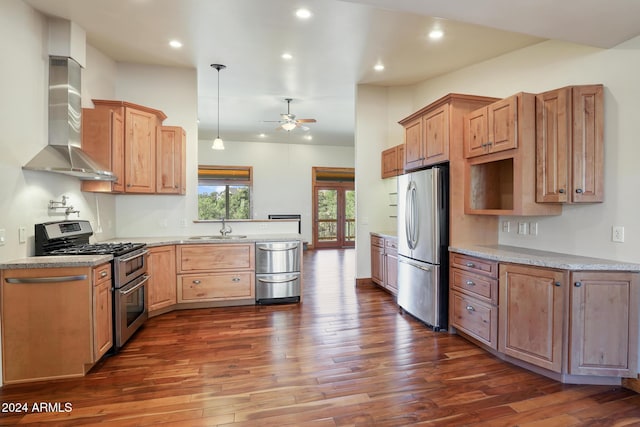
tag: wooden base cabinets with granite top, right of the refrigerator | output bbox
[450,246,640,384]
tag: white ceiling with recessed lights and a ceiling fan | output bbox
[25,0,640,145]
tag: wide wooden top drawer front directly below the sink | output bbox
[177,243,255,273]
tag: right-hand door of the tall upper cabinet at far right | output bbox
[571,85,604,203]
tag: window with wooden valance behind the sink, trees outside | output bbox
[198,166,253,219]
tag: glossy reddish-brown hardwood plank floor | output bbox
[0,250,640,427]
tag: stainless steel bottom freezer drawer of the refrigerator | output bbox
[398,255,447,330]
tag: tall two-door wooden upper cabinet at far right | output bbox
[536,85,604,203]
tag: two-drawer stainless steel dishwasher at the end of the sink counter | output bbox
[256,240,302,304]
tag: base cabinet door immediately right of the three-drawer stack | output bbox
[498,264,567,372]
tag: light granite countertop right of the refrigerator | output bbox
[449,245,640,272]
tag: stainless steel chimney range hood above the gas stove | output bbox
[22,19,117,181]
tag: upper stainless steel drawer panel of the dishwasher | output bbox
[256,241,302,274]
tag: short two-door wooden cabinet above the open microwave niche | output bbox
[464,94,521,158]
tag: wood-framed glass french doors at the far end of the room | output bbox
[313,182,356,248]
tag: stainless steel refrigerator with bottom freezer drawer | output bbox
[398,165,449,331]
